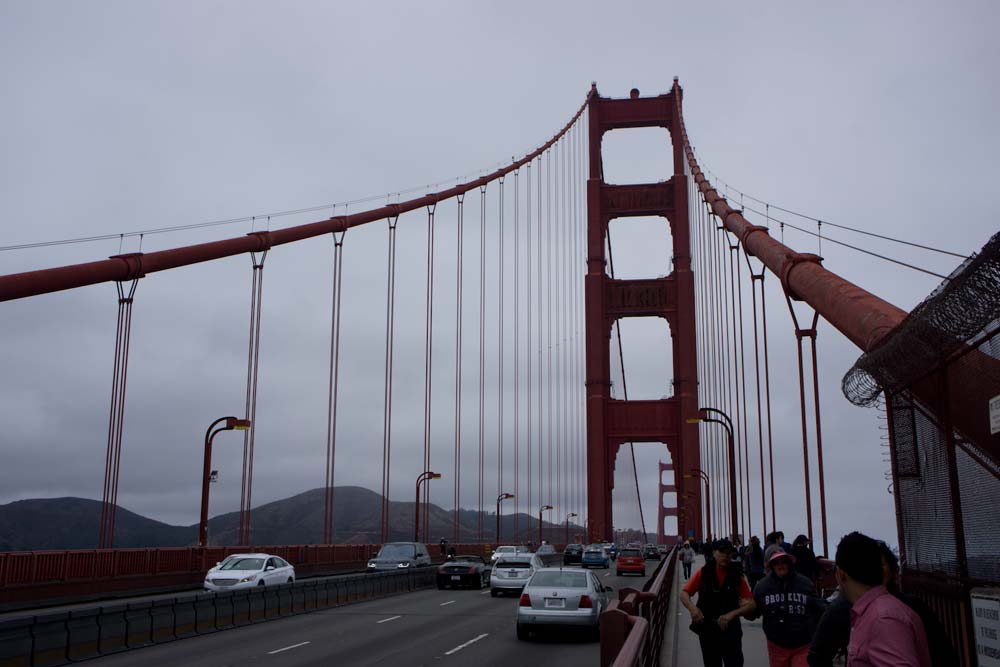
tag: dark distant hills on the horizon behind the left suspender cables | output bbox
[0,486,583,551]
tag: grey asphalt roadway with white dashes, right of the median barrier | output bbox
[88,561,656,667]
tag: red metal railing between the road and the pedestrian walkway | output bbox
[601,546,677,667]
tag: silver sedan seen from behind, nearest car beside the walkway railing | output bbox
[517,567,612,640]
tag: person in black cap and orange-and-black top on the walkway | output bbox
[681,539,753,667]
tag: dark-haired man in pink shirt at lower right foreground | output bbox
[836,532,931,667]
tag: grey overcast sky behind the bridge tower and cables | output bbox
[0,0,1000,544]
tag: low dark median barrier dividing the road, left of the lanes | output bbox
[0,567,435,667]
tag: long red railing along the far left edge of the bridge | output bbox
[0,544,490,610]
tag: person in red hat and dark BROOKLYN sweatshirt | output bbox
[753,551,824,667]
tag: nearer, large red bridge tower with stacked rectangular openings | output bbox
[584,80,701,541]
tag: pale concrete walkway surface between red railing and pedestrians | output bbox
[660,556,768,667]
